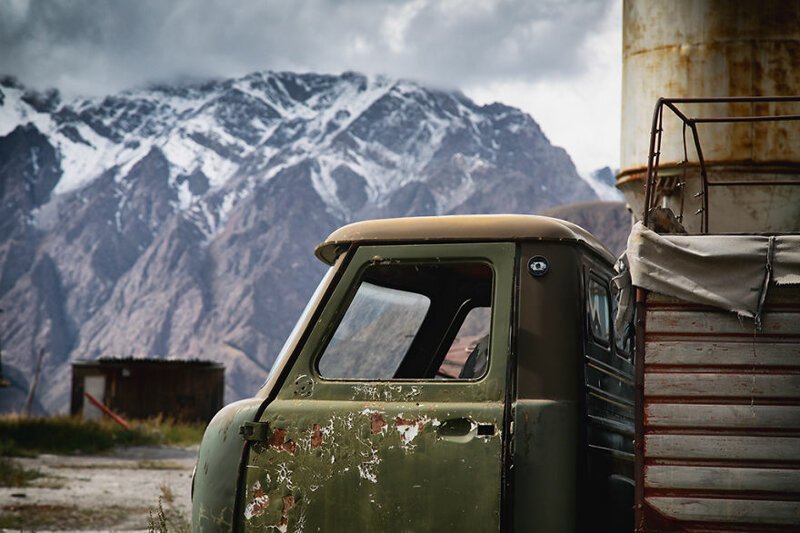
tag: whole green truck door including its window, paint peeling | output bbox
[238,243,516,531]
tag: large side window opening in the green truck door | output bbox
[317,262,492,380]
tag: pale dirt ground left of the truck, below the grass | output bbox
[0,447,197,531]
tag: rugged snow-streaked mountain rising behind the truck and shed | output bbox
[0,72,597,411]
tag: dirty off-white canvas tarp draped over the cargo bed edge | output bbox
[615,222,800,328]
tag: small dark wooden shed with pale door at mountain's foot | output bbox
[70,358,225,422]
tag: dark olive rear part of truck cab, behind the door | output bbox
[509,242,633,532]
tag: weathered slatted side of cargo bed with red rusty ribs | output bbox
[636,287,800,532]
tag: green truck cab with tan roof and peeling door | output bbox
[192,215,634,532]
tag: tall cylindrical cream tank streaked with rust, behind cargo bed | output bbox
[617,0,800,233]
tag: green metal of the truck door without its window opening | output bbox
[238,243,516,531]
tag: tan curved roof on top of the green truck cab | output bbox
[315,215,615,265]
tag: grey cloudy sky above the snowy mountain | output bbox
[0,0,622,171]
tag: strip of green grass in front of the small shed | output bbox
[0,415,204,457]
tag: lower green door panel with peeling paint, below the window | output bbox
[243,400,503,531]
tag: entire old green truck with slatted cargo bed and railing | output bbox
[192,97,800,532]
